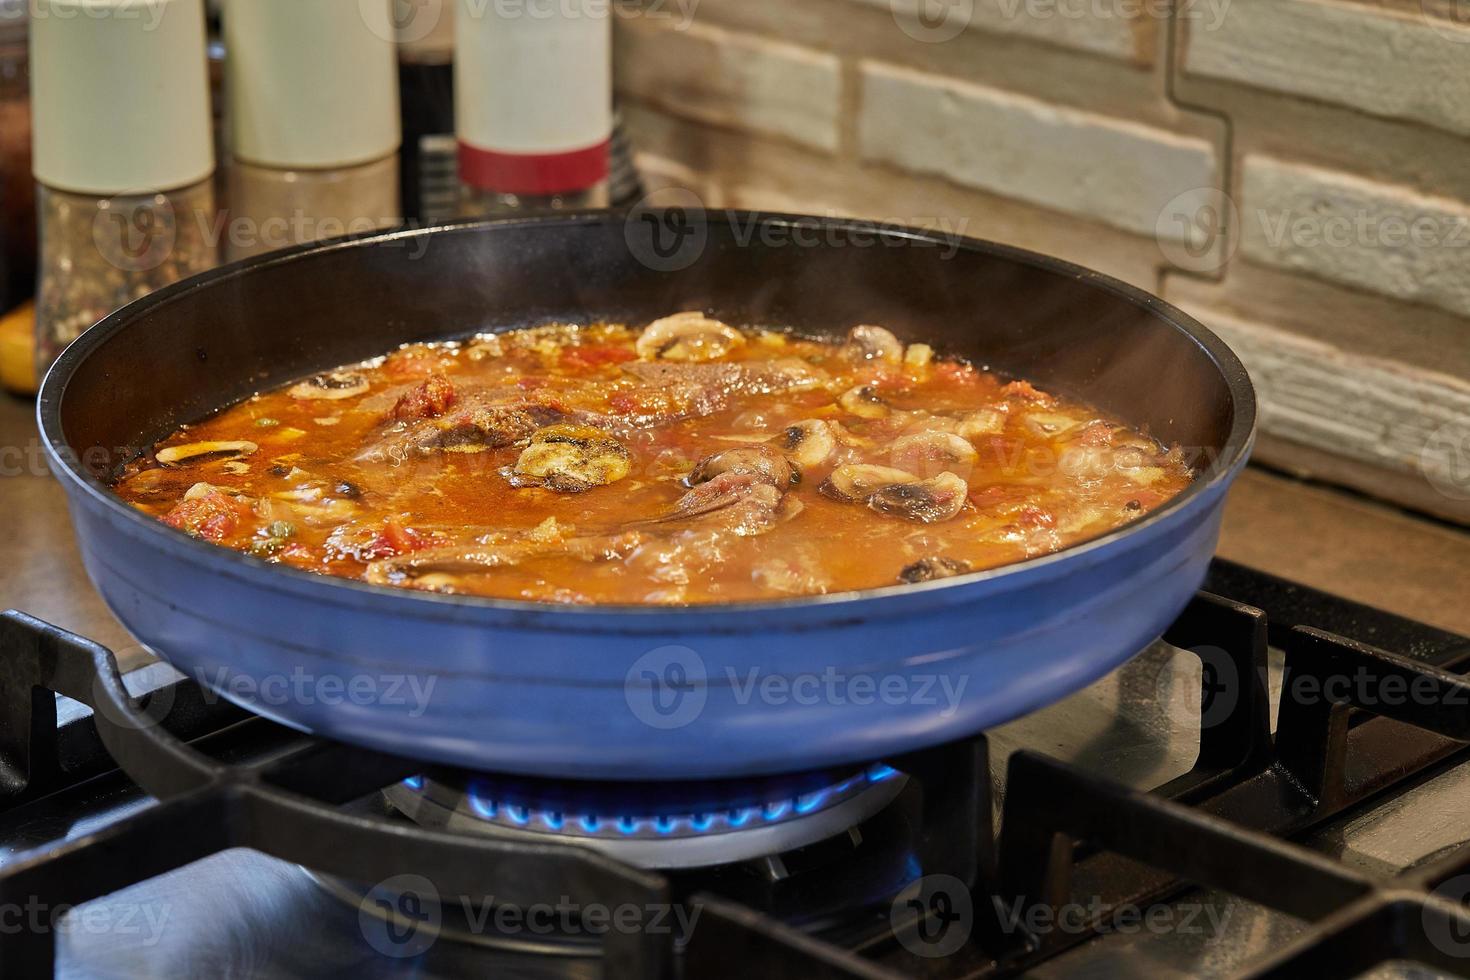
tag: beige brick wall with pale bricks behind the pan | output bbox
[616,0,1470,520]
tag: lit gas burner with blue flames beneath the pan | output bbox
[384,764,908,868]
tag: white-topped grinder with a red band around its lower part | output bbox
[454,0,613,216]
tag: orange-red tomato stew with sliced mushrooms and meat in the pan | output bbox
[115,313,1192,604]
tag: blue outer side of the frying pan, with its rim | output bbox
[40,214,1254,779]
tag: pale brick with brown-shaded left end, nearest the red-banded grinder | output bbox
[616,18,842,151]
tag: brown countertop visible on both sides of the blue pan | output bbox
[0,394,1470,669]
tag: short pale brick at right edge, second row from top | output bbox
[1239,155,1470,320]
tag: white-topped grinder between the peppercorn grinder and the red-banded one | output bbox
[223,0,401,259]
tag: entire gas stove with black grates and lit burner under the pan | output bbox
[0,561,1470,980]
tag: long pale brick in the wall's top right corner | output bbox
[1185,0,1470,134]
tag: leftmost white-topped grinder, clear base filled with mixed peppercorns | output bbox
[31,0,218,373]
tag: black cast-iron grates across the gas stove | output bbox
[0,561,1470,979]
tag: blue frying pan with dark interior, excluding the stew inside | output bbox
[38,212,1255,779]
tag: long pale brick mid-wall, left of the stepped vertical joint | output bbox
[858,62,1216,235]
